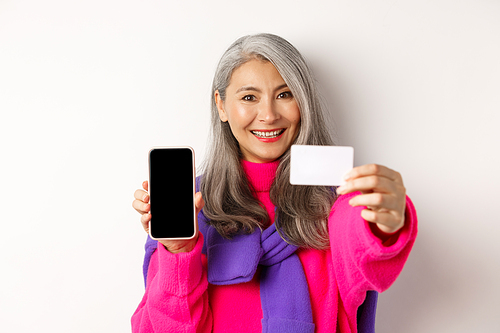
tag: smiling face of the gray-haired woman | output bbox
[215,60,300,163]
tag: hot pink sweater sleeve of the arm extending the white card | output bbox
[329,192,417,325]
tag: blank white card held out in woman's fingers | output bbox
[290,145,354,186]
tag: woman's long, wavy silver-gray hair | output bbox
[200,34,335,249]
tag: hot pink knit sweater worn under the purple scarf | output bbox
[132,161,417,333]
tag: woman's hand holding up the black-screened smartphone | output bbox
[132,181,205,253]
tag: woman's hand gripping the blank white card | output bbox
[337,164,406,234]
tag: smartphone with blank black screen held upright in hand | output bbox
[148,147,196,240]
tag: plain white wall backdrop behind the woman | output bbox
[0,0,500,333]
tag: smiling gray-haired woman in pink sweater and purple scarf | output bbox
[132,34,417,332]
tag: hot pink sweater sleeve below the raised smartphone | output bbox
[132,233,212,333]
